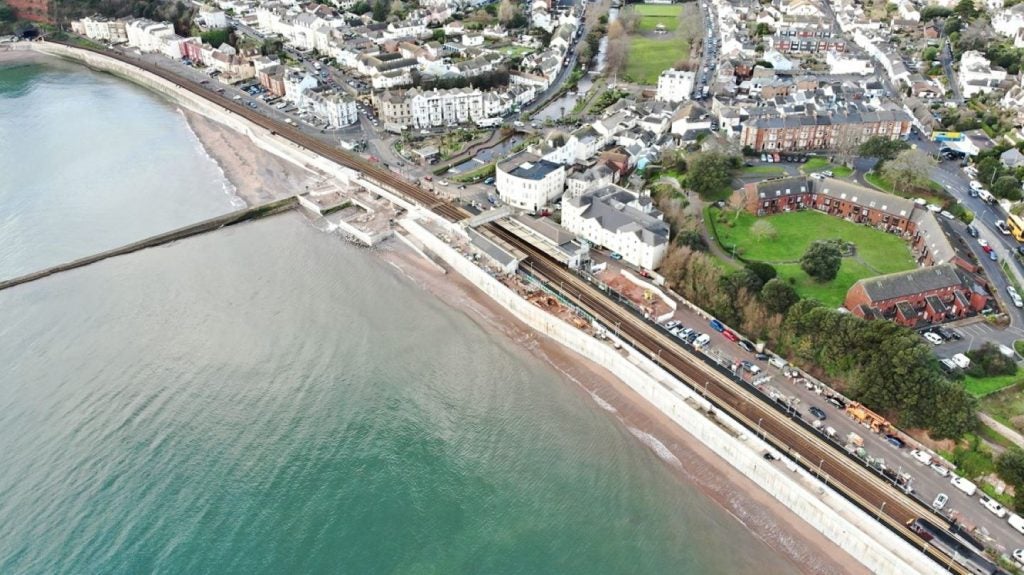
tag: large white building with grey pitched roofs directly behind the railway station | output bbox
[562,184,669,269]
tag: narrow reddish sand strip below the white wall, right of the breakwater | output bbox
[378,240,869,575]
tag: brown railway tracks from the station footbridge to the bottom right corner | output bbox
[486,222,970,574]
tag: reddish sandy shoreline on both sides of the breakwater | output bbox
[0,45,867,574]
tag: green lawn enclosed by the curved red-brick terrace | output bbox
[709,210,915,306]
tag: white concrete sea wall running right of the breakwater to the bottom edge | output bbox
[399,218,945,575]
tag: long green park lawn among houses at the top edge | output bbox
[624,3,698,85]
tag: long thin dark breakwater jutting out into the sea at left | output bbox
[0,196,298,291]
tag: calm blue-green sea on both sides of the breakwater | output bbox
[0,56,797,575]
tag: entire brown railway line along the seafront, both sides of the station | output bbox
[61,41,972,574]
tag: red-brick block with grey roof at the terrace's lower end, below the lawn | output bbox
[844,264,988,327]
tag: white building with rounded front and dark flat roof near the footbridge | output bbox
[495,150,565,212]
